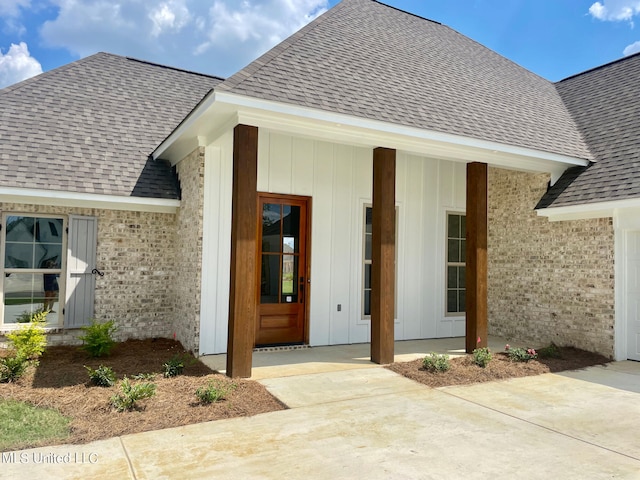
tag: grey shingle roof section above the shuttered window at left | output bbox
[0,53,222,198]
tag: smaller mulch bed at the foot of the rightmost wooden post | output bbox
[388,347,610,388]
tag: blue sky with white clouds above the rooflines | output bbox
[0,0,640,87]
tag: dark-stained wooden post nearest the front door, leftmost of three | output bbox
[227,125,258,377]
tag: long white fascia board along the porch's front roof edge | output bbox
[216,92,589,171]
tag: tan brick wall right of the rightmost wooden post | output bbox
[488,168,614,357]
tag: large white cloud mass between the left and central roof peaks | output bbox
[38,0,328,75]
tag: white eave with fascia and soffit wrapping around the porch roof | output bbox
[153,91,589,178]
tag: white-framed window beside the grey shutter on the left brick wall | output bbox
[2,214,66,325]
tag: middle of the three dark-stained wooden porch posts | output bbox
[371,148,396,364]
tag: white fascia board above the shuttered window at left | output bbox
[0,187,180,213]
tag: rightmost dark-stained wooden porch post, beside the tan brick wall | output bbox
[465,162,488,353]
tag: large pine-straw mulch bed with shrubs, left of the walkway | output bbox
[0,339,286,449]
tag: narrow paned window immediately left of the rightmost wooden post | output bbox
[446,213,467,315]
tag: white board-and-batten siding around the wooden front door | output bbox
[200,129,466,354]
